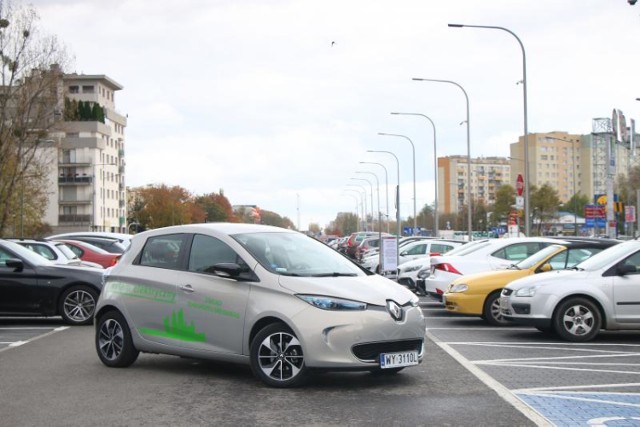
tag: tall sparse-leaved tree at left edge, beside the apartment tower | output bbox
[0,0,66,234]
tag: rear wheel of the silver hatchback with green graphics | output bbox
[95,310,140,368]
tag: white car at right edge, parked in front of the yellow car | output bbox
[500,240,640,342]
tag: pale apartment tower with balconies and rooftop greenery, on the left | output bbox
[44,74,127,233]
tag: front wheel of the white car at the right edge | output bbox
[553,297,602,342]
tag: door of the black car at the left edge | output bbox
[0,248,43,314]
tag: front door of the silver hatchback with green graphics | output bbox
[177,234,255,354]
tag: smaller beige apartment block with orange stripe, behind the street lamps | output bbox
[438,156,511,214]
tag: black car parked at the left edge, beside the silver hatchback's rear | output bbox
[0,240,104,325]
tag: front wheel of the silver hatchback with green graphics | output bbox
[250,322,309,388]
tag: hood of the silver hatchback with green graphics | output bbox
[279,274,417,306]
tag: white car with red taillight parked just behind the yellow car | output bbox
[418,237,563,301]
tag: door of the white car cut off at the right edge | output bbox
[613,252,640,329]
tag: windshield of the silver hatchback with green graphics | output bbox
[232,232,366,277]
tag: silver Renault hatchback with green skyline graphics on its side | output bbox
[95,223,425,387]
